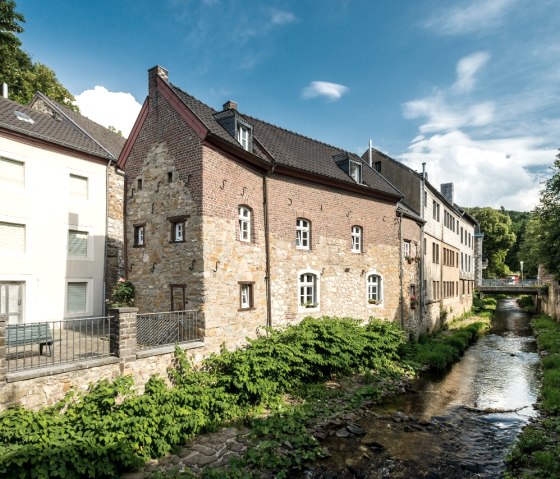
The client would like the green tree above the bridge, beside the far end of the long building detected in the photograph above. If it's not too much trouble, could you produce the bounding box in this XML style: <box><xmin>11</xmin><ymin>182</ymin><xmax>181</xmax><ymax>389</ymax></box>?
<box><xmin>467</xmin><ymin>207</ymin><xmax>515</xmax><ymax>278</ymax></box>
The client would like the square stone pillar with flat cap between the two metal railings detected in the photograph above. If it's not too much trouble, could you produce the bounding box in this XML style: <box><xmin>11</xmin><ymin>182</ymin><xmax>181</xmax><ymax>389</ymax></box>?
<box><xmin>109</xmin><ymin>308</ymin><xmax>138</xmax><ymax>374</ymax></box>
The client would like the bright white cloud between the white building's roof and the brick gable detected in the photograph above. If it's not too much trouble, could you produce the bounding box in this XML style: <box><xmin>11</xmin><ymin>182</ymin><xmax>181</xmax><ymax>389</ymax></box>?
<box><xmin>76</xmin><ymin>85</ymin><xmax>142</xmax><ymax>137</ymax></box>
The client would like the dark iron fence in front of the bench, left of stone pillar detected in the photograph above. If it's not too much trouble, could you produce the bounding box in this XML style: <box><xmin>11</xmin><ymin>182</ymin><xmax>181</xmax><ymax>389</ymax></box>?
<box><xmin>5</xmin><ymin>316</ymin><xmax>111</xmax><ymax>371</ymax></box>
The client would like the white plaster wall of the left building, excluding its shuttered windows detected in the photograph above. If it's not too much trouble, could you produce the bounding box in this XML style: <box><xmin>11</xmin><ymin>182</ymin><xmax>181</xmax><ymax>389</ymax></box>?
<box><xmin>0</xmin><ymin>136</ymin><xmax>107</xmax><ymax>323</ymax></box>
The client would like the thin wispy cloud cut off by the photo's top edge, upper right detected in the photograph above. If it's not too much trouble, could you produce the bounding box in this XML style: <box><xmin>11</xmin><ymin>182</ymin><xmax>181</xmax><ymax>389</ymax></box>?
<box><xmin>424</xmin><ymin>0</ymin><xmax>517</xmax><ymax>35</ymax></box>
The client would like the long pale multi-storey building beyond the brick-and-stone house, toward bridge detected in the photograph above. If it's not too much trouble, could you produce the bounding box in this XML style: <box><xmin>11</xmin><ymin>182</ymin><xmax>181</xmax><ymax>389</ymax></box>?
<box><xmin>362</xmin><ymin>148</ymin><xmax>476</xmax><ymax>329</ymax></box>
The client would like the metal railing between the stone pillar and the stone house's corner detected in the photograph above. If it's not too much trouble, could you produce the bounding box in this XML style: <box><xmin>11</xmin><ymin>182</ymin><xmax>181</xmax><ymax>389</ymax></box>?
<box><xmin>136</xmin><ymin>310</ymin><xmax>203</xmax><ymax>349</ymax></box>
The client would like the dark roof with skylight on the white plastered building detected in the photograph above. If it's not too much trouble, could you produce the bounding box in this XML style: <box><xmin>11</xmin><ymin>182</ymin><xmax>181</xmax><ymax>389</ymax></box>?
<box><xmin>0</xmin><ymin>95</ymin><xmax>125</xmax><ymax>160</ymax></box>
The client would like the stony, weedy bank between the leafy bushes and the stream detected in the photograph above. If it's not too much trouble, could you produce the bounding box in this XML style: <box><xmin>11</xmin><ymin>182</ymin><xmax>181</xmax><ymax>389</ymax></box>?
<box><xmin>137</xmin><ymin>314</ymin><xmax>490</xmax><ymax>479</ymax></box>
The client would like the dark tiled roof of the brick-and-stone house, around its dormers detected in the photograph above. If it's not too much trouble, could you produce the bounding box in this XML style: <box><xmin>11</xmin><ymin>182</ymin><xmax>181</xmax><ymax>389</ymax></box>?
<box><xmin>168</xmin><ymin>82</ymin><xmax>403</xmax><ymax>198</ymax></box>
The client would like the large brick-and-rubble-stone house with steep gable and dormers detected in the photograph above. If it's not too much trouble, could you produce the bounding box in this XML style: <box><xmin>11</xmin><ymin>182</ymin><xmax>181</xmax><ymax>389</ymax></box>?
<box><xmin>119</xmin><ymin>66</ymin><xmax>423</xmax><ymax>349</ymax></box>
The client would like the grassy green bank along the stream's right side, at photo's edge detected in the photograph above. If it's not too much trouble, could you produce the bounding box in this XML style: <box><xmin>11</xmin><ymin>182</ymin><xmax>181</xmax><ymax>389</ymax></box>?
<box><xmin>506</xmin><ymin>316</ymin><xmax>560</xmax><ymax>479</ymax></box>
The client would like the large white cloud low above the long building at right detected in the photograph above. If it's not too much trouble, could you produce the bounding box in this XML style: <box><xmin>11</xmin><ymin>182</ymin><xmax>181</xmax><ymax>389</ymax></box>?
<box><xmin>401</xmin><ymin>130</ymin><xmax>556</xmax><ymax>211</ymax></box>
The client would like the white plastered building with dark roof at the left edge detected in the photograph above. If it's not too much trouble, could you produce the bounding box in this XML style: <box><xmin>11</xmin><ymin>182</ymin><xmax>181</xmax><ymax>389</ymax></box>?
<box><xmin>0</xmin><ymin>93</ymin><xmax>124</xmax><ymax>323</ymax></box>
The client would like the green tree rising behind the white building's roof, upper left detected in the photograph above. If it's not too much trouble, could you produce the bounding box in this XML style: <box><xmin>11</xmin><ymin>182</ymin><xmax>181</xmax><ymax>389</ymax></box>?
<box><xmin>0</xmin><ymin>0</ymin><xmax>78</xmax><ymax>111</ymax></box>
